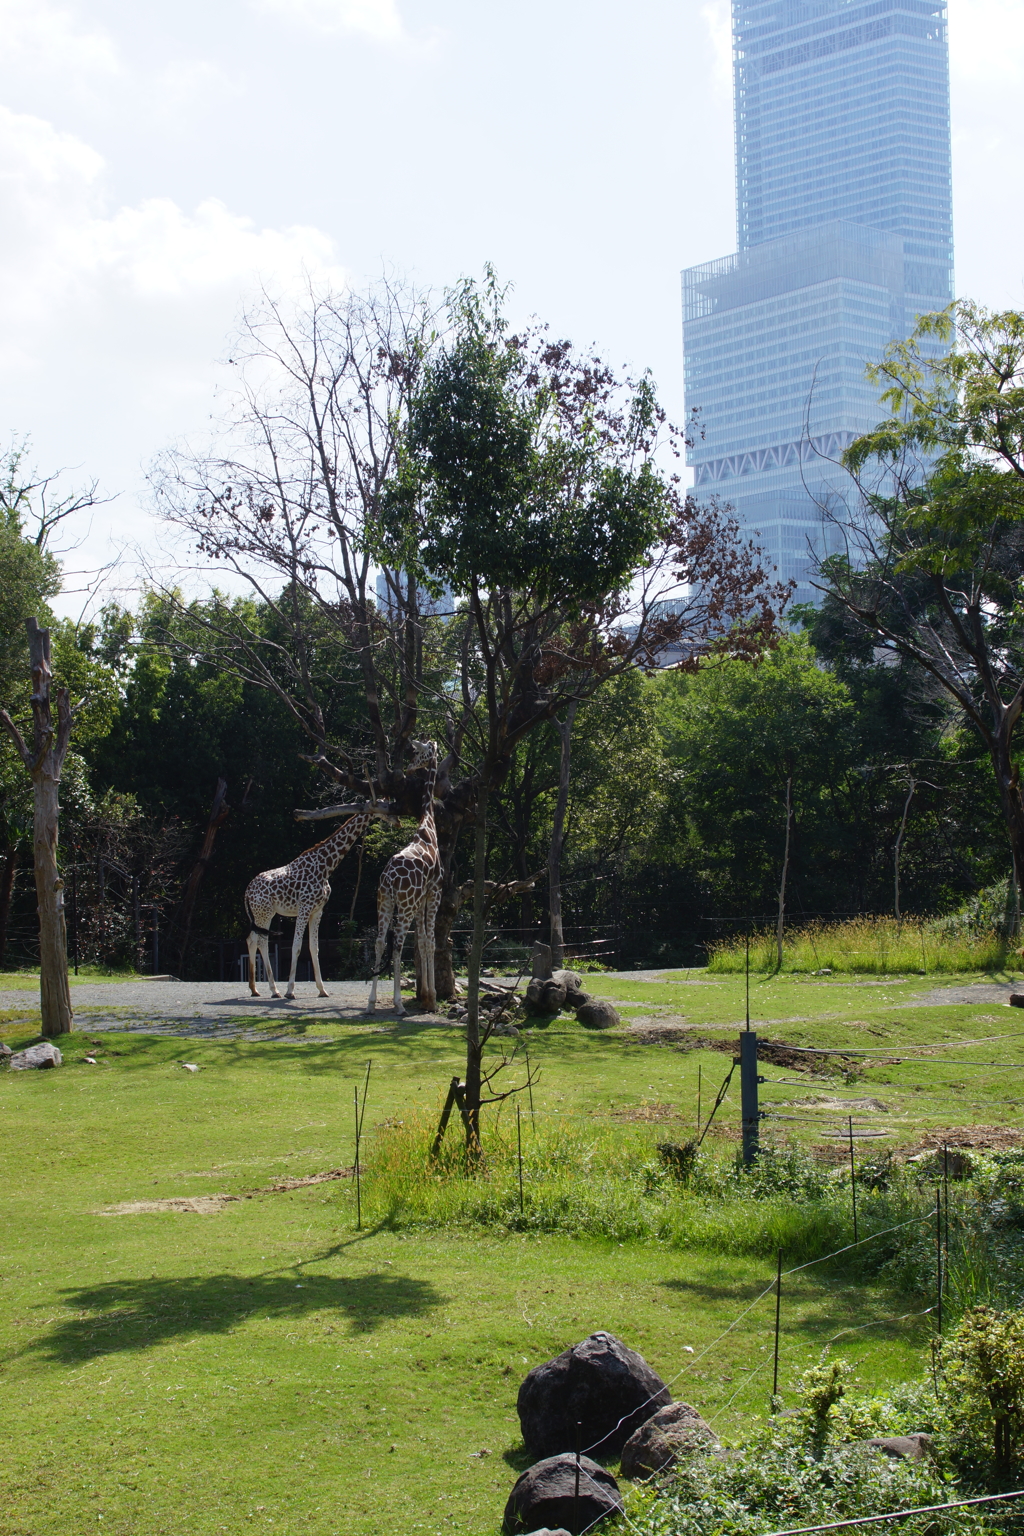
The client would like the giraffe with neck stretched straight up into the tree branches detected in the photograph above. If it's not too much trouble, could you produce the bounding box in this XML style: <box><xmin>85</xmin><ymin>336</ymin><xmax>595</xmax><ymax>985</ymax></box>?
<box><xmin>367</xmin><ymin>742</ymin><xmax>442</xmax><ymax>1018</ymax></box>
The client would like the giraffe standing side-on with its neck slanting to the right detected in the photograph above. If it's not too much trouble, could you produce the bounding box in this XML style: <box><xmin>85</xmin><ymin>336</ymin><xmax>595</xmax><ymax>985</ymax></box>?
<box><xmin>246</xmin><ymin>802</ymin><xmax>399</xmax><ymax>997</ymax></box>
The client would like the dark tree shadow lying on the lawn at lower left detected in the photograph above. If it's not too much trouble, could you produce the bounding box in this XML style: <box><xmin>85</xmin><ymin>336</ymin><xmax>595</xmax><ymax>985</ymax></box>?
<box><xmin>28</xmin><ymin>1273</ymin><xmax>445</xmax><ymax>1364</ymax></box>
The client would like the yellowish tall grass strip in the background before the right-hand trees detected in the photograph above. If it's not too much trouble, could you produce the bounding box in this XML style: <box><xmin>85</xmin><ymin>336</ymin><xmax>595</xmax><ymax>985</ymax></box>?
<box><xmin>708</xmin><ymin>917</ymin><xmax>1009</xmax><ymax>975</ymax></box>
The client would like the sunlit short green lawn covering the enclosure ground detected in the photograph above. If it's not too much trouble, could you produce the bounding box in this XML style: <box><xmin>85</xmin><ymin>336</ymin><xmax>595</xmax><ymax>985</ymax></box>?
<box><xmin>0</xmin><ymin>972</ymin><xmax>1024</xmax><ymax>1536</ymax></box>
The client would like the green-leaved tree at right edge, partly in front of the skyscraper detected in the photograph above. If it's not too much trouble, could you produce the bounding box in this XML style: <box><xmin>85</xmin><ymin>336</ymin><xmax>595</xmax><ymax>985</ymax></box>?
<box><xmin>821</xmin><ymin>301</ymin><xmax>1024</xmax><ymax>922</ymax></box>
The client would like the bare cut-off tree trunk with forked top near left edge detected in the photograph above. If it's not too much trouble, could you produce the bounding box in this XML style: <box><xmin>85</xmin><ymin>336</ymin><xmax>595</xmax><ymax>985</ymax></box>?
<box><xmin>0</xmin><ymin>619</ymin><xmax>75</xmax><ymax>1040</ymax></box>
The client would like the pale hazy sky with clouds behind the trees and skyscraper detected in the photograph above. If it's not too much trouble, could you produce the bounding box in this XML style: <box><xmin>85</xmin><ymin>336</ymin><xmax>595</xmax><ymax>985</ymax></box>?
<box><xmin>0</xmin><ymin>0</ymin><xmax>1024</xmax><ymax>599</ymax></box>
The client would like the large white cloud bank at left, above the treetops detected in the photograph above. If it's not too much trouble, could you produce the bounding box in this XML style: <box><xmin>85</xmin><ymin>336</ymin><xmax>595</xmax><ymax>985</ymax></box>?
<box><xmin>0</xmin><ymin>106</ymin><xmax>345</xmax><ymax>561</ymax></box>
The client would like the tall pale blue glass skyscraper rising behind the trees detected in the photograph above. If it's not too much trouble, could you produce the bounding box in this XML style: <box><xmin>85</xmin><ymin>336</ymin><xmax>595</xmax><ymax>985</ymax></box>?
<box><xmin>683</xmin><ymin>0</ymin><xmax>953</xmax><ymax>601</ymax></box>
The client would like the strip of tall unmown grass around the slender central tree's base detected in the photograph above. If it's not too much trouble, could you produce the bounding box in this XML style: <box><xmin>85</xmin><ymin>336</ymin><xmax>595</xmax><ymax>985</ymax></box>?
<box><xmin>364</xmin><ymin>1117</ymin><xmax>939</xmax><ymax>1272</ymax></box>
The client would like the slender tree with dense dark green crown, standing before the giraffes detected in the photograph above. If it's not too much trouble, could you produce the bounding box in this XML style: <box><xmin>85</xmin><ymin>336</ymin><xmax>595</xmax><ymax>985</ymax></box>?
<box><xmin>381</xmin><ymin>272</ymin><xmax>774</xmax><ymax>1144</ymax></box>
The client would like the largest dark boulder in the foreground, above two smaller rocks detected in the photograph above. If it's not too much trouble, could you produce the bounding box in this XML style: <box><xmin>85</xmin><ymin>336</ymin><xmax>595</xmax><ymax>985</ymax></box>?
<box><xmin>516</xmin><ymin>1332</ymin><xmax>672</xmax><ymax>1456</ymax></box>
